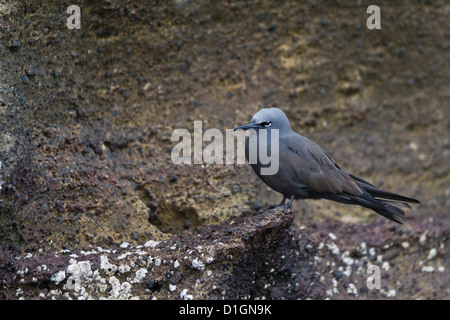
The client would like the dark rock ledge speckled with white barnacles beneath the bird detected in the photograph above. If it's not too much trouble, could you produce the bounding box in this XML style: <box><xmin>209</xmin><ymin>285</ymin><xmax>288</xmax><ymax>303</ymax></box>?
<box><xmin>0</xmin><ymin>208</ymin><xmax>450</xmax><ymax>300</ymax></box>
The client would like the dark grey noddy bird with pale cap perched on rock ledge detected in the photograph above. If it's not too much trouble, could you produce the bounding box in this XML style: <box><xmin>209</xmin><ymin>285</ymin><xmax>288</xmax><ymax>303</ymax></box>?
<box><xmin>234</xmin><ymin>108</ymin><xmax>420</xmax><ymax>223</ymax></box>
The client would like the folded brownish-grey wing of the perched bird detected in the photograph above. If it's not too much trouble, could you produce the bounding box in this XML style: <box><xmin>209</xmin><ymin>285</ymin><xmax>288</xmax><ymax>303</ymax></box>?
<box><xmin>280</xmin><ymin>134</ymin><xmax>363</xmax><ymax>195</ymax></box>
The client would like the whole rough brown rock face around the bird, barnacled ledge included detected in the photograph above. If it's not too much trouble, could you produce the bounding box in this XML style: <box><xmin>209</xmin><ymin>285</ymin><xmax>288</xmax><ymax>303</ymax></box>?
<box><xmin>0</xmin><ymin>1</ymin><xmax>450</xmax><ymax>299</ymax></box>
